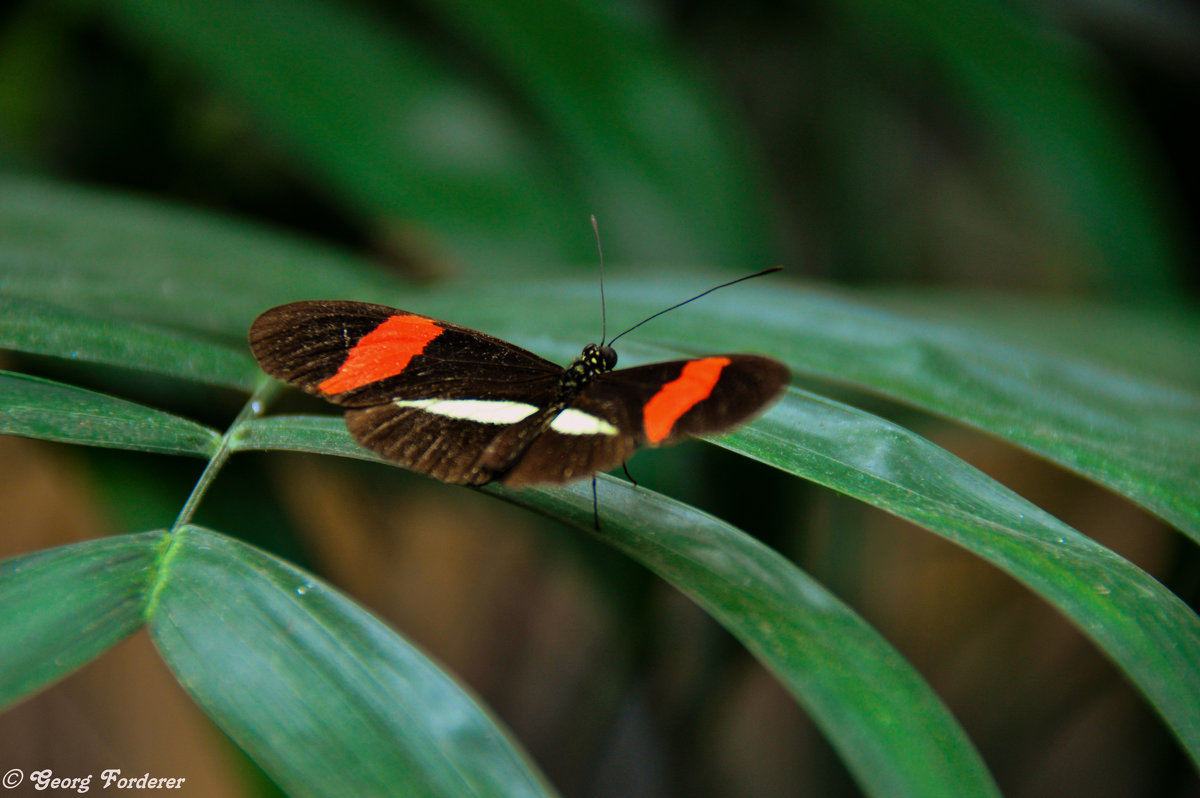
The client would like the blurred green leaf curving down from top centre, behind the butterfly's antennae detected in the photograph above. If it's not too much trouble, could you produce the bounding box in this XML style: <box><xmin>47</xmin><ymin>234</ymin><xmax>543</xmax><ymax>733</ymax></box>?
<box><xmin>412</xmin><ymin>0</ymin><xmax>768</xmax><ymax>269</ymax></box>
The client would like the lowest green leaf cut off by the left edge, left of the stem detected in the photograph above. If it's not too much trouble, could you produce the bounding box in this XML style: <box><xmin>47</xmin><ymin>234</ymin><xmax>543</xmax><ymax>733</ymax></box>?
<box><xmin>0</xmin><ymin>532</ymin><xmax>163</xmax><ymax>707</ymax></box>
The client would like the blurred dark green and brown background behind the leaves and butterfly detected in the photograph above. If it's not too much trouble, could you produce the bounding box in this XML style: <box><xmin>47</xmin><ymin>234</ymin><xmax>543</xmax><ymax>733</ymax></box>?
<box><xmin>0</xmin><ymin>0</ymin><xmax>1200</xmax><ymax>796</ymax></box>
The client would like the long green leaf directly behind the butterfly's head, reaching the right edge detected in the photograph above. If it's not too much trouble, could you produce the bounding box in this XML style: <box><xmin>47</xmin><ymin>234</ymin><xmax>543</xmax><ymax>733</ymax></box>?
<box><xmin>434</xmin><ymin>277</ymin><xmax>1200</xmax><ymax>540</ymax></box>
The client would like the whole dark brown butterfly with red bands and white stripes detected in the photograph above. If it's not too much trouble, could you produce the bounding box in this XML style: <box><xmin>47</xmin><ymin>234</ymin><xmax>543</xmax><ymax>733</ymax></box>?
<box><xmin>250</xmin><ymin>300</ymin><xmax>788</xmax><ymax>487</ymax></box>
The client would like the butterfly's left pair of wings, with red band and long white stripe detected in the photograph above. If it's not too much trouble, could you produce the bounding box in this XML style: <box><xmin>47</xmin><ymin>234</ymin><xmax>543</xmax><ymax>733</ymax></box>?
<box><xmin>250</xmin><ymin>301</ymin><xmax>563</xmax><ymax>485</ymax></box>
